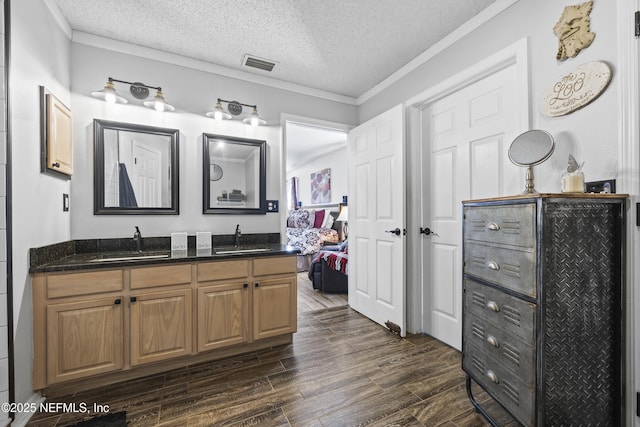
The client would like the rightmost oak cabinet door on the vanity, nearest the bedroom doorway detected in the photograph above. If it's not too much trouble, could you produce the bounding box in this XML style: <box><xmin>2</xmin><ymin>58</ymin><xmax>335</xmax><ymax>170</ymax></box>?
<box><xmin>253</xmin><ymin>275</ymin><xmax>298</xmax><ymax>340</ymax></box>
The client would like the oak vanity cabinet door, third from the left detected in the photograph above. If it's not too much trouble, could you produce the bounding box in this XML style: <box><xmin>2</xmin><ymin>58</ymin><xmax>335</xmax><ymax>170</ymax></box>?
<box><xmin>198</xmin><ymin>282</ymin><xmax>249</xmax><ymax>351</ymax></box>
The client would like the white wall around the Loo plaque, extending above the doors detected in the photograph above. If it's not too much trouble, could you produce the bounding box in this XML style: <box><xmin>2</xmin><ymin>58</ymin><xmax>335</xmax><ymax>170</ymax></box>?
<box><xmin>359</xmin><ymin>0</ymin><xmax>632</xmax><ymax>192</ymax></box>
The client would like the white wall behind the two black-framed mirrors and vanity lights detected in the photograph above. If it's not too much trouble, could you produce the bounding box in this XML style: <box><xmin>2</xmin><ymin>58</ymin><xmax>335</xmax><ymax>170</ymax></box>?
<box><xmin>71</xmin><ymin>43</ymin><xmax>356</xmax><ymax>239</ymax></box>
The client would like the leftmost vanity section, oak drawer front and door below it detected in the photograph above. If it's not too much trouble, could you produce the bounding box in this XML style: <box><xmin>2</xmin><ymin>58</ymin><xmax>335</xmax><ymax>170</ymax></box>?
<box><xmin>33</xmin><ymin>270</ymin><xmax>124</xmax><ymax>388</ymax></box>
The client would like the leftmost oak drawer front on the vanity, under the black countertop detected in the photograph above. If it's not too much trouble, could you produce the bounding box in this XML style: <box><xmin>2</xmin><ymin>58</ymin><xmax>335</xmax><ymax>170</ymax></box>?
<box><xmin>47</xmin><ymin>270</ymin><xmax>124</xmax><ymax>298</ymax></box>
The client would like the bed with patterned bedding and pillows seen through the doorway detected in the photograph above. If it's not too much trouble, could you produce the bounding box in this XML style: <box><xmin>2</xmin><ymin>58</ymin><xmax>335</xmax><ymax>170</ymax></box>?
<box><xmin>287</xmin><ymin>209</ymin><xmax>340</xmax><ymax>271</ymax></box>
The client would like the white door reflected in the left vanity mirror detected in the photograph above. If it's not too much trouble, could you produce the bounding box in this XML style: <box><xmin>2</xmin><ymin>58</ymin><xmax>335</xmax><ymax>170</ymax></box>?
<box><xmin>132</xmin><ymin>141</ymin><xmax>163</xmax><ymax>207</ymax></box>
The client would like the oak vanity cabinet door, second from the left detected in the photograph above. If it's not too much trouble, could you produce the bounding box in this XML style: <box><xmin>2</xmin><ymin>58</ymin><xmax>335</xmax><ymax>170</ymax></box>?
<box><xmin>129</xmin><ymin>289</ymin><xmax>193</xmax><ymax>366</ymax></box>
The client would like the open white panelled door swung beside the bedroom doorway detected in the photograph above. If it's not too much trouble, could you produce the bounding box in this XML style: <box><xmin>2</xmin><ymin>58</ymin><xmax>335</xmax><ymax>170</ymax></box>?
<box><xmin>348</xmin><ymin>105</ymin><xmax>406</xmax><ymax>336</ymax></box>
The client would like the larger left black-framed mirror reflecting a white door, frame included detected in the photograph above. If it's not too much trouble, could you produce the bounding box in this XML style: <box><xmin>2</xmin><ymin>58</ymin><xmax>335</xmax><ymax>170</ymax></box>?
<box><xmin>93</xmin><ymin>119</ymin><xmax>180</xmax><ymax>215</ymax></box>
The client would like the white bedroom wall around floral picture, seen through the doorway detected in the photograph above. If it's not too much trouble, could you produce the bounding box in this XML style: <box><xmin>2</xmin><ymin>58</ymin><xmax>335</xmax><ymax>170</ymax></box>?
<box><xmin>283</xmin><ymin>146</ymin><xmax>348</xmax><ymax>206</ymax></box>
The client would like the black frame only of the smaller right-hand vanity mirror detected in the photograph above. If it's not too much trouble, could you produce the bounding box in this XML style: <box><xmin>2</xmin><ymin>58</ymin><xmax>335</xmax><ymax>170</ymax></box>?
<box><xmin>202</xmin><ymin>133</ymin><xmax>267</xmax><ymax>215</ymax></box>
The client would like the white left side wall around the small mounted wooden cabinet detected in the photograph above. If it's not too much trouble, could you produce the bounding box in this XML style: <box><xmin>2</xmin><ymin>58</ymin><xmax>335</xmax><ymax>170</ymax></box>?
<box><xmin>10</xmin><ymin>0</ymin><xmax>75</xmax><ymax>412</ymax></box>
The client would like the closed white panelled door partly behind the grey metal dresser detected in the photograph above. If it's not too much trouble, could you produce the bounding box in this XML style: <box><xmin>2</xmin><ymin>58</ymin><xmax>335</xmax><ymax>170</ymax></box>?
<box><xmin>421</xmin><ymin>66</ymin><xmax>524</xmax><ymax>349</ymax></box>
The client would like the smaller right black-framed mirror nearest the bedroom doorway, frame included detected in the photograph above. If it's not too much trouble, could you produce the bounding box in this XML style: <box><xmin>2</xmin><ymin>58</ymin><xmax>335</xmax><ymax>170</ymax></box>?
<box><xmin>202</xmin><ymin>133</ymin><xmax>267</xmax><ymax>214</ymax></box>
